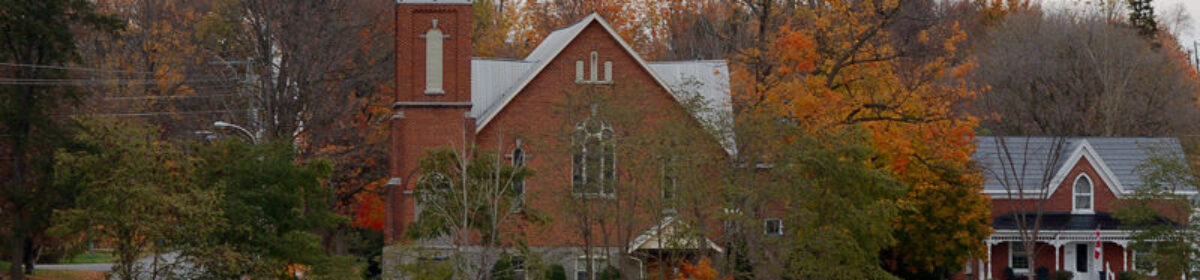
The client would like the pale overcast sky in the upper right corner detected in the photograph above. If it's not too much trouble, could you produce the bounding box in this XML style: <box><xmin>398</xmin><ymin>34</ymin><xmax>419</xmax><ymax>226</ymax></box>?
<box><xmin>1034</xmin><ymin>0</ymin><xmax>1200</xmax><ymax>49</ymax></box>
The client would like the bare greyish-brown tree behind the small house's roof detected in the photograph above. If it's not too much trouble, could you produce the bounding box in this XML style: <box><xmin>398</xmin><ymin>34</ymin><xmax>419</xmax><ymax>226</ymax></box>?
<box><xmin>970</xmin><ymin>11</ymin><xmax>1200</xmax><ymax>136</ymax></box>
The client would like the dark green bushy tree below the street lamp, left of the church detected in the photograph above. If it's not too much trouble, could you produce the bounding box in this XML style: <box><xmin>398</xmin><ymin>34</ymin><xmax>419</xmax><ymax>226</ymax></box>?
<box><xmin>181</xmin><ymin>141</ymin><xmax>358</xmax><ymax>279</ymax></box>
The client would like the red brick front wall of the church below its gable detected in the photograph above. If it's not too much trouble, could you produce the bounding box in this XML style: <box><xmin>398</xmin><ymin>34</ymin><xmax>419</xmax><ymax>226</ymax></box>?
<box><xmin>478</xmin><ymin>23</ymin><xmax>724</xmax><ymax>246</ymax></box>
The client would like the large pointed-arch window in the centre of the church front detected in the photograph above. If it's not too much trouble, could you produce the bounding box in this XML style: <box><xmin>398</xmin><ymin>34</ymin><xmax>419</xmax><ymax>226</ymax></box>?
<box><xmin>571</xmin><ymin>106</ymin><xmax>617</xmax><ymax>197</ymax></box>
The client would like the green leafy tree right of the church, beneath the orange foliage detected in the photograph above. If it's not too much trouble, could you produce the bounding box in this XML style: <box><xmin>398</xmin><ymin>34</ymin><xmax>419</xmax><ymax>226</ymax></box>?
<box><xmin>775</xmin><ymin>130</ymin><xmax>906</xmax><ymax>279</ymax></box>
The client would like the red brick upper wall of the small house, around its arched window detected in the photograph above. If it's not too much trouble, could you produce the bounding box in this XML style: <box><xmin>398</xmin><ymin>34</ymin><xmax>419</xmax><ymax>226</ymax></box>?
<box><xmin>991</xmin><ymin>157</ymin><xmax>1116</xmax><ymax>218</ymax></box>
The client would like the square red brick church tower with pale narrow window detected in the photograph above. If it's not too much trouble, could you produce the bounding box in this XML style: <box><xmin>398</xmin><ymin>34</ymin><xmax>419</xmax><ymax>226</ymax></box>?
<box><xmin>384</xmin><ymin>0</ymin><xmax>475</xmax><ymax>244</ymax></box>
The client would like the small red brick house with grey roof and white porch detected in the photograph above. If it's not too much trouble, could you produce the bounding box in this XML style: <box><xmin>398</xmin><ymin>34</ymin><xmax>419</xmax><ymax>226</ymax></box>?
<box><xmin>965</xmin><ymin>137</ymin><xmax>1195</xmax><ymax>280</ymax></box>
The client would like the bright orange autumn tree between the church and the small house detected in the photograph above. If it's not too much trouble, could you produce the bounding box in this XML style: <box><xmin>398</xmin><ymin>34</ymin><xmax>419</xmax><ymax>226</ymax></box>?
<box><xmin>739</xmin><ymin>0</ymin><xmax>990</xmax><ymax>278</ymax></box>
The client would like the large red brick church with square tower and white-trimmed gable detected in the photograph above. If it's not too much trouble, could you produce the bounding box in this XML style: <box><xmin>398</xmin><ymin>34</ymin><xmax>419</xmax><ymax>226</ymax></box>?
<box><xmin>384</xmin><ymin>0</ymin><xmax>734</xmax><ymax>279</ymax></box>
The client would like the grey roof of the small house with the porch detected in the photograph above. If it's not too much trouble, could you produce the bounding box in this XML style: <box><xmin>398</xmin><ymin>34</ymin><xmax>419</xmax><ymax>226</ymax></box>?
<box><xmin>972</xmin><ymin>136</ymin><xmax>1184</xmax><ymax>192</ymax></box>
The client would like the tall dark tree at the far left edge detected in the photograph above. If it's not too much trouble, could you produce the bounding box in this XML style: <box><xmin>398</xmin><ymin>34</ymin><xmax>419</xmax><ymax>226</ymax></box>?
<box><xmin>0</xmin><ymin>0</ymin><xmax>120</xmax><ymax>280</ymax></box>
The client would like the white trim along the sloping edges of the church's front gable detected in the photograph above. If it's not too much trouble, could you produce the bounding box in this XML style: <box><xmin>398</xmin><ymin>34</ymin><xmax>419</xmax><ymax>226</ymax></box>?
<box><xmin>475</xmin><ymin>13</ymin><xmax>703</xmax><ymax>133</ymax></box>
